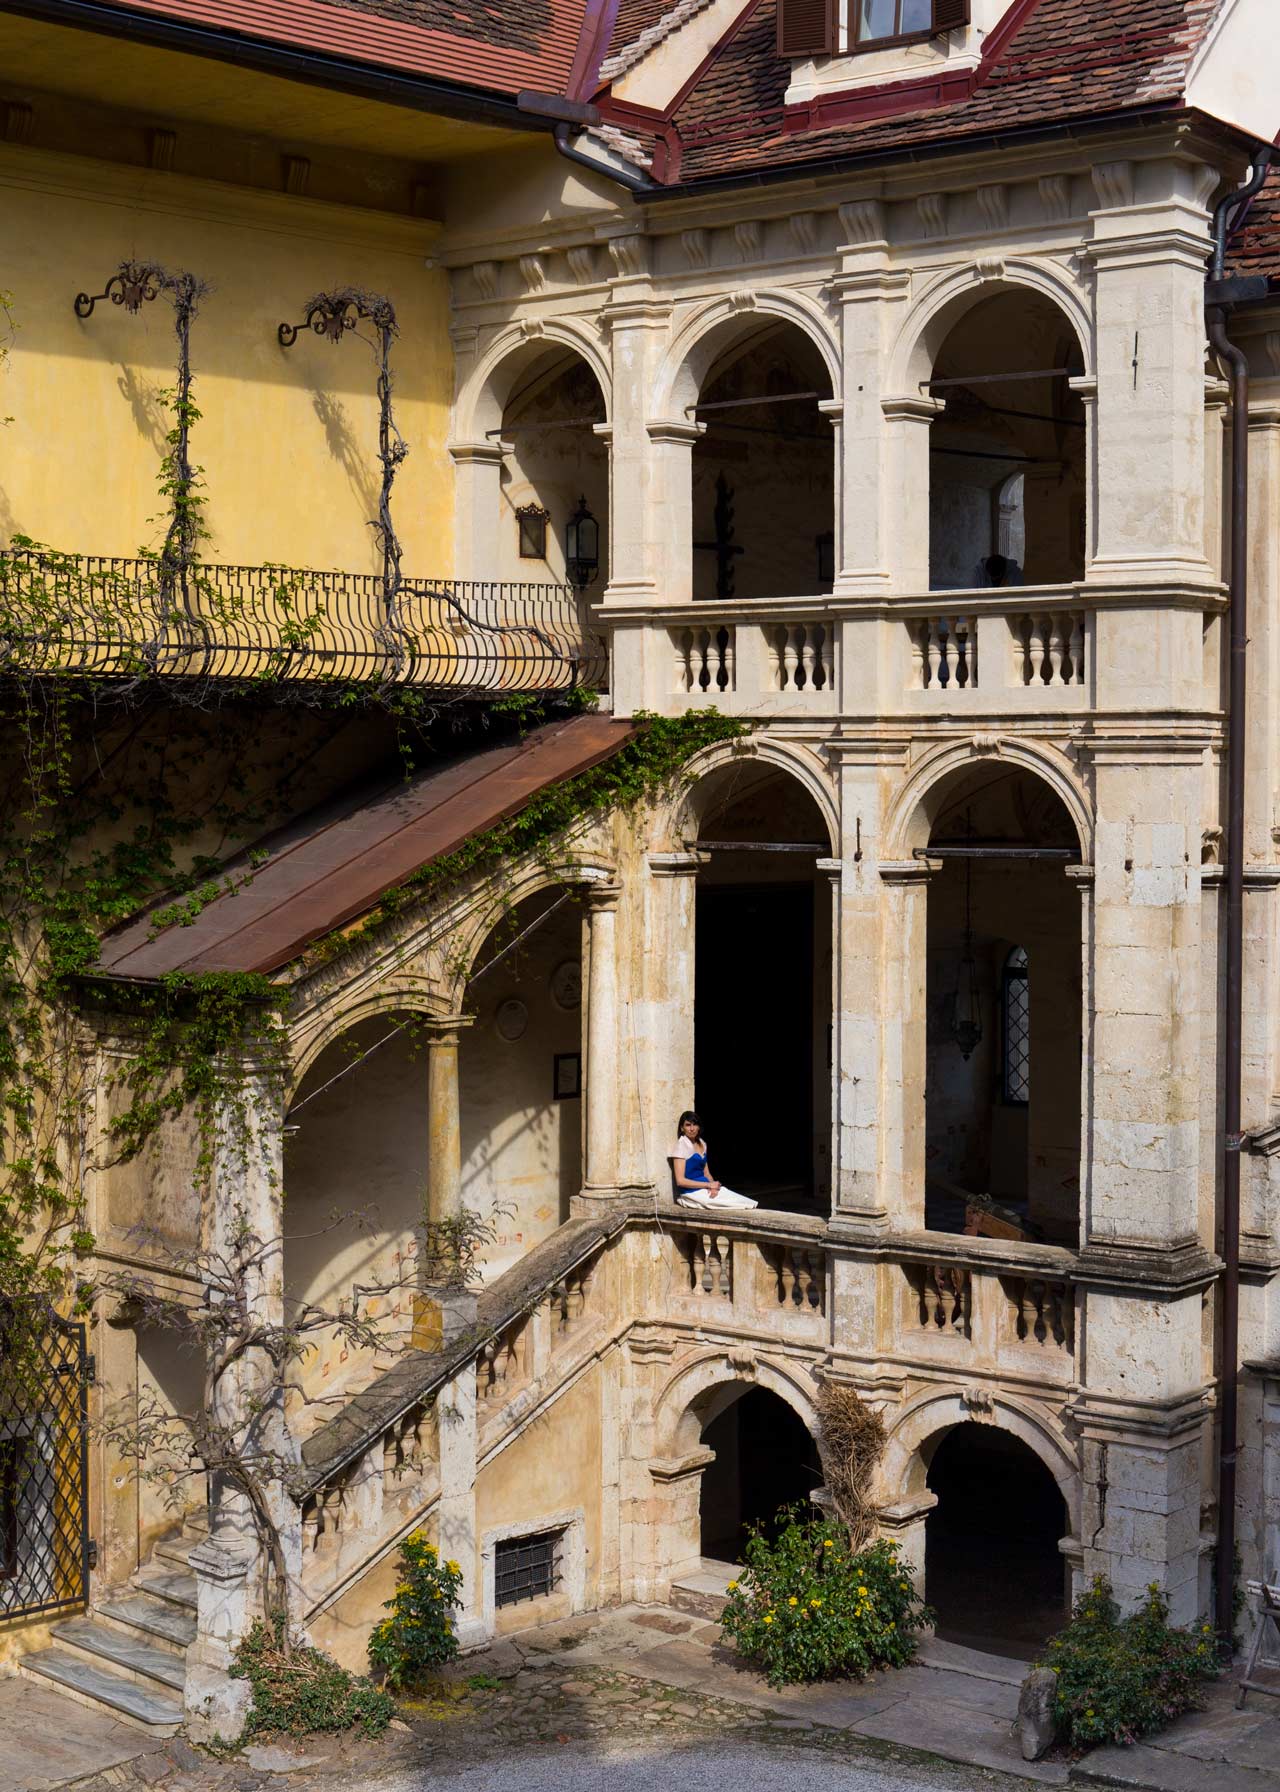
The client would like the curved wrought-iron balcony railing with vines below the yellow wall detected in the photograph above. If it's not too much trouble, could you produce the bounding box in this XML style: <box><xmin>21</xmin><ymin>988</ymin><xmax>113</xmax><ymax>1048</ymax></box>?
<box><xmin>0</xmin><ymin>547</ymin><xmax>606</xmax><ymax>695</ymax></box>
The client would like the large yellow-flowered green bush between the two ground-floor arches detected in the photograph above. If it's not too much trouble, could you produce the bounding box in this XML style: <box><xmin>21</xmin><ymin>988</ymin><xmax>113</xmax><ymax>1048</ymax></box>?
<box><xmin>721</xmin><ymin>1505</ymin><xmax>930</xmax><ymax>1686</ymax></box>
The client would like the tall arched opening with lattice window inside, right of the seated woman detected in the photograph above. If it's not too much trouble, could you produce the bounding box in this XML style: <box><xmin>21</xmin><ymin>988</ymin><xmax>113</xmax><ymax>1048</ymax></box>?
<box><xmin>923</xmin><ymin>762</ymin><xmax>1083</xmax><ymax>1245</ymax></box>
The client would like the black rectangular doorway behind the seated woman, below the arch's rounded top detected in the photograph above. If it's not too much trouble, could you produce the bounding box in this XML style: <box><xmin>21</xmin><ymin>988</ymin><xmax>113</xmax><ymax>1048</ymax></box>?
<box><xmin>694</xmin><ymin>882</ymin><xmax>814</xmax><ymax>1208</ymax></box>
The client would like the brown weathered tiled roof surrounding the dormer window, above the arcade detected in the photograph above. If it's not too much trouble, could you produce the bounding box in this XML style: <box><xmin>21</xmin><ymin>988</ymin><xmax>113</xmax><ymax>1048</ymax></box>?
<box><xmin>604</xmin><ymin>0</ymin><xmax>1221</xmax><ymax>185</ymax></box>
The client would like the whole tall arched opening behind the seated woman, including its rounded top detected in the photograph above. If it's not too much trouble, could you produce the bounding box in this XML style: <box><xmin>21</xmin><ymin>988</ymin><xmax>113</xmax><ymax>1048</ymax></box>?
<box><xmin>692</xmin><ymin>760</ymin><xmax>832</xmax><ymax>1211</ymax></box>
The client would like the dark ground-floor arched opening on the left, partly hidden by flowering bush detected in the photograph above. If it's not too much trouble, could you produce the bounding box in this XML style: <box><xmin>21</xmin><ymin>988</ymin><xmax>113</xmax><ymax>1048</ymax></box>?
<box><xmin>701</xmin><ymin>1387</ymin><xmax>823</xmax><ymax>1563</ymax></box>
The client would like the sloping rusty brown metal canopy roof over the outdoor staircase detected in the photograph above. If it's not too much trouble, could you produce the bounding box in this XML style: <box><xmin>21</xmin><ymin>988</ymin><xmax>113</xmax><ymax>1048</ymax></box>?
<box><xmin>99</xmin><ymin>715</ymin><xmax>636</xmax><ymax>978</ymax></box>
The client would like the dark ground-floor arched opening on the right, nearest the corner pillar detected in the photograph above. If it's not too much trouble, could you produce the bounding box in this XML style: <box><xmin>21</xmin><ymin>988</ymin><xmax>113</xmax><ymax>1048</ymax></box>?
<box><xmin>925</xmin><ymin>1425</ymin><xmax>1068</xmax><ymax>1661</ymax></box>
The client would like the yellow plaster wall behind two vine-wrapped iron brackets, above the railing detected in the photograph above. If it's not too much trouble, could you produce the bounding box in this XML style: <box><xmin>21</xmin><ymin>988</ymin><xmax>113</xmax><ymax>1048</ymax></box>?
<box><xmin>0</xmin><ymin>145</ymin><xmax>452</xmax><ymax>575</ymax></box>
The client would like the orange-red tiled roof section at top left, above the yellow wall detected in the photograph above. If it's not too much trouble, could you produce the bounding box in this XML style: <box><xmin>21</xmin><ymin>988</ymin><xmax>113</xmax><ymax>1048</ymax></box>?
<box><xmin>87</xmin><ymin>0</ymin><xmax>599</xmax><ymax>97</ymax></box>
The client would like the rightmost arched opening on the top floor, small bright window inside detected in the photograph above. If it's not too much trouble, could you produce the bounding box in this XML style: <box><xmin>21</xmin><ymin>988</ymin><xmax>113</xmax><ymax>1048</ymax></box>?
<box><xmin>929</xmin><ymin>290</ymin><xmax>1086</xmax><ymax>591</ymax></box>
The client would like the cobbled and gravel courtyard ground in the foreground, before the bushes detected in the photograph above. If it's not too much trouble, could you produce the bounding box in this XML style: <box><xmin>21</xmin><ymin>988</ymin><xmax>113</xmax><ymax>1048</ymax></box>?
<box><xmin>24</xmin><ymin>1607</ymin><xmax>1280</xmax><ymax>1792</ymax></box>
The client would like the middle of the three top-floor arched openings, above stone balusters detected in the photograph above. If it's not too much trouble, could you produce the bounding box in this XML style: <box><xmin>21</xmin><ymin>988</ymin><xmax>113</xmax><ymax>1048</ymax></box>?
<box><xmin>692</xmin><ymin>315</ymin><xmax>835</xmax><ymax>602</ymax></box>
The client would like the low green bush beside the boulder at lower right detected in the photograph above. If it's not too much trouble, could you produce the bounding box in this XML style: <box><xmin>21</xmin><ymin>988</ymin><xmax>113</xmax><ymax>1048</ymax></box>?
<box><xmin>1043</xmin><ymin>1575</ymin><xmax>1221</xmax><ymax>1747</ymax></box>
